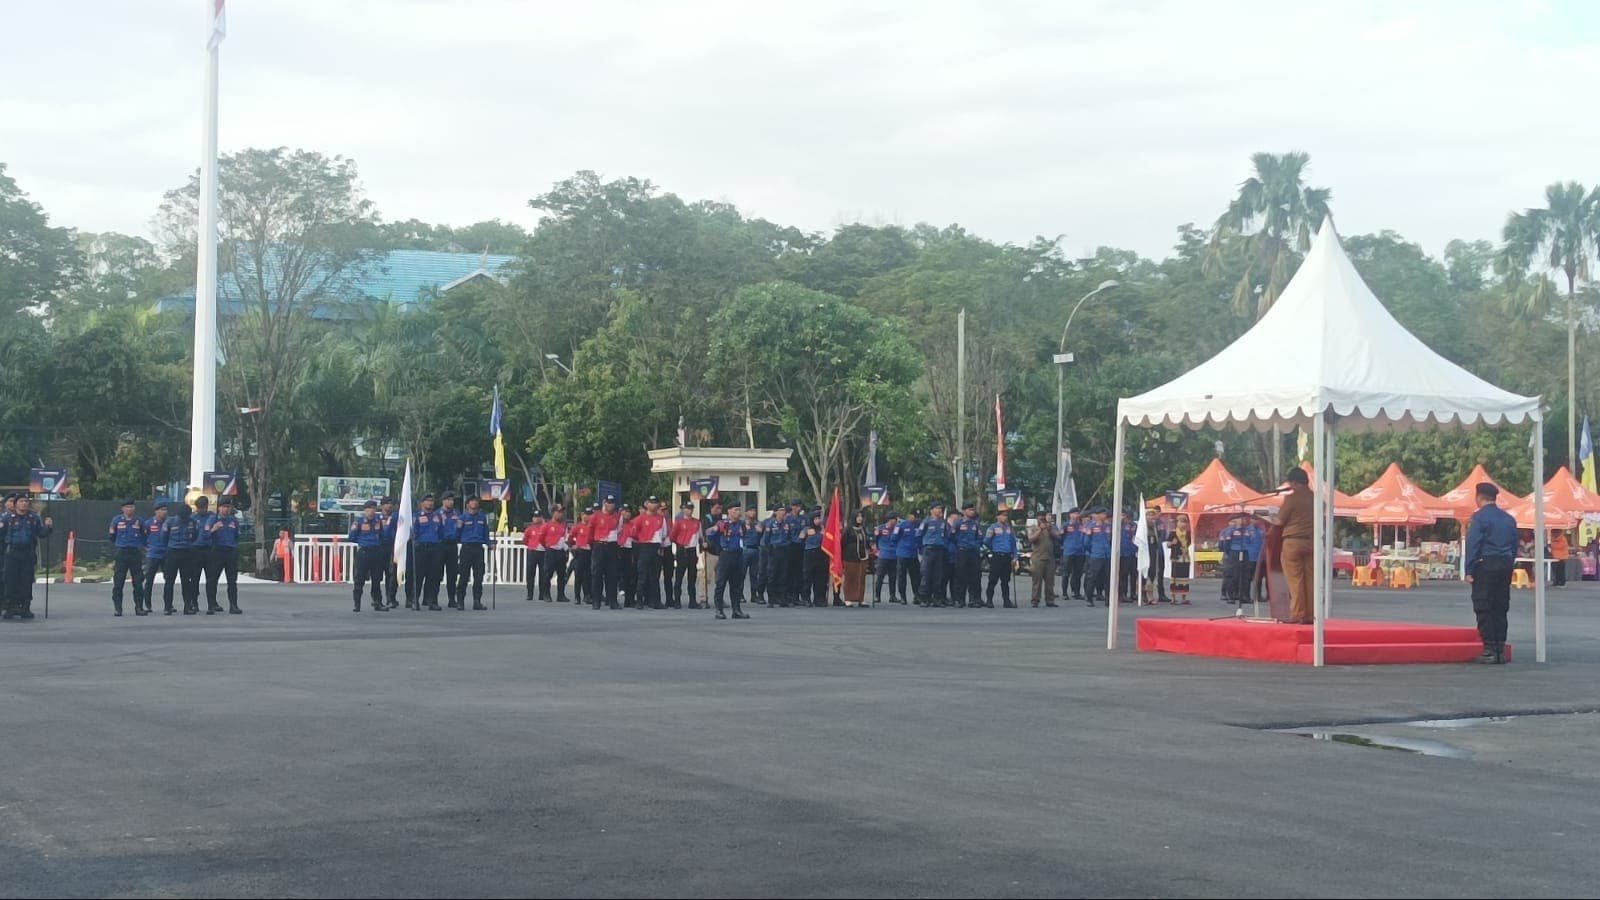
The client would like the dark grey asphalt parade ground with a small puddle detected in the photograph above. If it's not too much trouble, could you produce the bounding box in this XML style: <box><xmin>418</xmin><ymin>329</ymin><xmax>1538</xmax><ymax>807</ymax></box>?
<box><xmin>0</xmin><ymin>570</ymin><xmax>1600</xmax><ymax>897</ymax></box>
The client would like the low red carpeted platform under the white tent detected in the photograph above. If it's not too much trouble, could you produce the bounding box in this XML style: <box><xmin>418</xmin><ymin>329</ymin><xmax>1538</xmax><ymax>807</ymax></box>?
<box><xmin>1138</xmin><ymin>618</ymin><xmax>1510</xmax><ymax>666</ymax></box>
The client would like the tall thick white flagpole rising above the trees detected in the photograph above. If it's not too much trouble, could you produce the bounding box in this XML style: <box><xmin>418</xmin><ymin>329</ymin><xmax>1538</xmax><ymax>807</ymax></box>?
<box><xmin>189</xmin><ymin>0</ymin><xmax>224</xmax><ymax>488</ymax></box>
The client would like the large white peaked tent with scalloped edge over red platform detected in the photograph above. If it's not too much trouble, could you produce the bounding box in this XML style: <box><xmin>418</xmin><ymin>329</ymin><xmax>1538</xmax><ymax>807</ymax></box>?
<box><xmin>1106</xmin><ymin>218</ymin><xmax>1546</xmax><ymax>666</ymax></box>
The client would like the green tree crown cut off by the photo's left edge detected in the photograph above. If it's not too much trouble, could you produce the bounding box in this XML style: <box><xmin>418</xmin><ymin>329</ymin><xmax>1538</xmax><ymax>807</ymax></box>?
<box><xmin>0</xmin><ymin>163</ymin><xmax>82</xmax><ymax>320</ymax></box>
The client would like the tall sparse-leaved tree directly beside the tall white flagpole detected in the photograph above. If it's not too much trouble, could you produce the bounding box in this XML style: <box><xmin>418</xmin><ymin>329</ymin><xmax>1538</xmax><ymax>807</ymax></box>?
<box><xmin>157</xmin><ymin>147</ymin><xmax>378</xmax><ymax>565</ymax></box>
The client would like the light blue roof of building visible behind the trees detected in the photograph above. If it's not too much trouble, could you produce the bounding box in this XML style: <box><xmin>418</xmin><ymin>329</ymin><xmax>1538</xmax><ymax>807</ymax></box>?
<box><xmin>155</xmin><ymin>250</ymin><xmax>515</xmax><ymax>319</ymax></box>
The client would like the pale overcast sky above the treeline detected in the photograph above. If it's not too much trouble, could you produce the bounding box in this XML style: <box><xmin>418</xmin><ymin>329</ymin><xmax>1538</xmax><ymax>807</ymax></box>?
<box><xmin>0</xmin><ymin>0</ymin><xmax>1600</xmax><ymax>256</ymax></box>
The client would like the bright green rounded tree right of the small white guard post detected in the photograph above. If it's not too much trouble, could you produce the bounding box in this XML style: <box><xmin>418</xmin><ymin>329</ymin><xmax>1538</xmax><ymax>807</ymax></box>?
<box><xmin>710</xmin><ymin>282</ymin><xmax>920</xmax><ymax>503</ymax></box>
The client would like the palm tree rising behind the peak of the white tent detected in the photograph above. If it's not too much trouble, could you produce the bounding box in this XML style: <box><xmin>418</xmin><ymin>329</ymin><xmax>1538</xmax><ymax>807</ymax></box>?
<box><xmin>1206</xmin><ymin>151</ymin><xmax>1333</xmax><ymax>319</ymax></box>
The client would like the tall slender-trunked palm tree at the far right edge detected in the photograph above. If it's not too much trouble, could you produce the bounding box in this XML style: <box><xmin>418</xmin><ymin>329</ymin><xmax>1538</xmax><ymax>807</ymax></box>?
<box><xmin>1494</xmin><ymin>181</ymin><xmax>1600</xmax><ymax>472</ymax></box>
